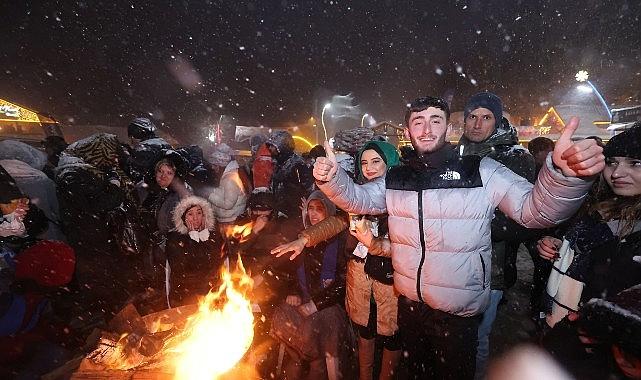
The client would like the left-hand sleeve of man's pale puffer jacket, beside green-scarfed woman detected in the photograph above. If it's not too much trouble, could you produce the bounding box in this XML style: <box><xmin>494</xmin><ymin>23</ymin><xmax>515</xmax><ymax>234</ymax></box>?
<box><xmin>316</xmin><ymin>168</ymin><xmax>387</xmax><ymax>215</ymax></box>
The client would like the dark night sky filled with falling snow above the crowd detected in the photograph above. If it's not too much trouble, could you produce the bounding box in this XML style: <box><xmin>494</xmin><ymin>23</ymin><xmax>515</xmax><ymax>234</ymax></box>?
<box><xmin>0</xmin><ymin>0</ymin><xmax>641</xmax><ymax>142</ymax></box>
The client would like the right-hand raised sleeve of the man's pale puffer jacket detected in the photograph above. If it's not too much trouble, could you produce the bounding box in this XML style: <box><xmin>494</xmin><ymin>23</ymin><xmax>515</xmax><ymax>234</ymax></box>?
<box><xmin>480</xmin><ymin>155</ymin><xmax>593</xmax><ymax>228</ymax></box>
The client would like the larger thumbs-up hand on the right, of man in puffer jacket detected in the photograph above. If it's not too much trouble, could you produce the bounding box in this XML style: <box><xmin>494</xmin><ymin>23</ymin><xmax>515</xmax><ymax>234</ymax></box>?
<box><xmin>552</xmin><ymin>117</ymin><xmax>605</xmax><ymax>177</ymax></box>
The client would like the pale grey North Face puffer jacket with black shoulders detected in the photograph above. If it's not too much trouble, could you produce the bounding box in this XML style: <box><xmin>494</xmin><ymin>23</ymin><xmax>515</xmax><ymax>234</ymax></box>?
<box><xmin>319</xmin><ymin>153</ymin><xmax>591</xmax><ymax>316</ymax></box>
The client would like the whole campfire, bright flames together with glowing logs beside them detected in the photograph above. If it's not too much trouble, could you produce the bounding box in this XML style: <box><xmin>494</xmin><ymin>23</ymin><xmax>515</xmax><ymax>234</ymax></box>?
<box><xmin>80</xmin><ymin>258</ymin><xmax>254</xmax><ymax>379</ymax></box>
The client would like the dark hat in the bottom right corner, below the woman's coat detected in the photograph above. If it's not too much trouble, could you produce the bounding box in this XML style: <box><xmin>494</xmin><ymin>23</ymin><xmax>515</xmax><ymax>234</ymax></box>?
<box><xmin>580</xmin><ymin>285</ymin><xmax>641</xmax><ymax>358</ymax></box>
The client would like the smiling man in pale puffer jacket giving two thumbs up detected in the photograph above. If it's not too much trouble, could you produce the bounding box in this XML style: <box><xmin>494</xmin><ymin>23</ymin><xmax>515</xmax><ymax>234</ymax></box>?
<box><xmin>314</xmin><ymin>97</ymin><xmax>604</xmax><ymax>379</ymax></box>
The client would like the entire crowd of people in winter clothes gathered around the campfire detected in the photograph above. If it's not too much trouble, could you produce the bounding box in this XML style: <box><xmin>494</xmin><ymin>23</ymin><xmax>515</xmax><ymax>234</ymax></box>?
<box><xmin>0</xmin><ymin>92</ymin><xmax>641</xmax><ymax>380</ymax></box>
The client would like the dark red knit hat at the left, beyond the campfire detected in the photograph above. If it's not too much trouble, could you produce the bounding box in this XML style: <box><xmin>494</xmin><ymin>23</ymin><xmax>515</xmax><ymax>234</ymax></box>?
<box><xmin>15</xmin><ymin>240</ymin><xmax>76</xmax><ymax>286</ymax></box>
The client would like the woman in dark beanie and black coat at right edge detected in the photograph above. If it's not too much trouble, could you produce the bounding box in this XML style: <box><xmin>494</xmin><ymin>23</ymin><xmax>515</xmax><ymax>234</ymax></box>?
<box><xmin>538</xmin><ymin>122</ymin><xmax>641</xmax><ymax>379</ymax></box>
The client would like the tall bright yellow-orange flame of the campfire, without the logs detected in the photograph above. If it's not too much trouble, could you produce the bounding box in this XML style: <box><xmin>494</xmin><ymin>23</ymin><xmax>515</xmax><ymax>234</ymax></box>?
<box><xmin>171</xmin><ymin>257</ymin><xmax>254</xmax><ymax>379</ymax></box>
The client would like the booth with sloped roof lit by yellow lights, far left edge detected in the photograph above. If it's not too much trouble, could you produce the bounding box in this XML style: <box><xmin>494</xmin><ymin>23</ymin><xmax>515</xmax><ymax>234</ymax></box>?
<box><xmin>0</xmin><ymin>99</ymin><xmax>62</xmax><ymax>145</ymax></box>
